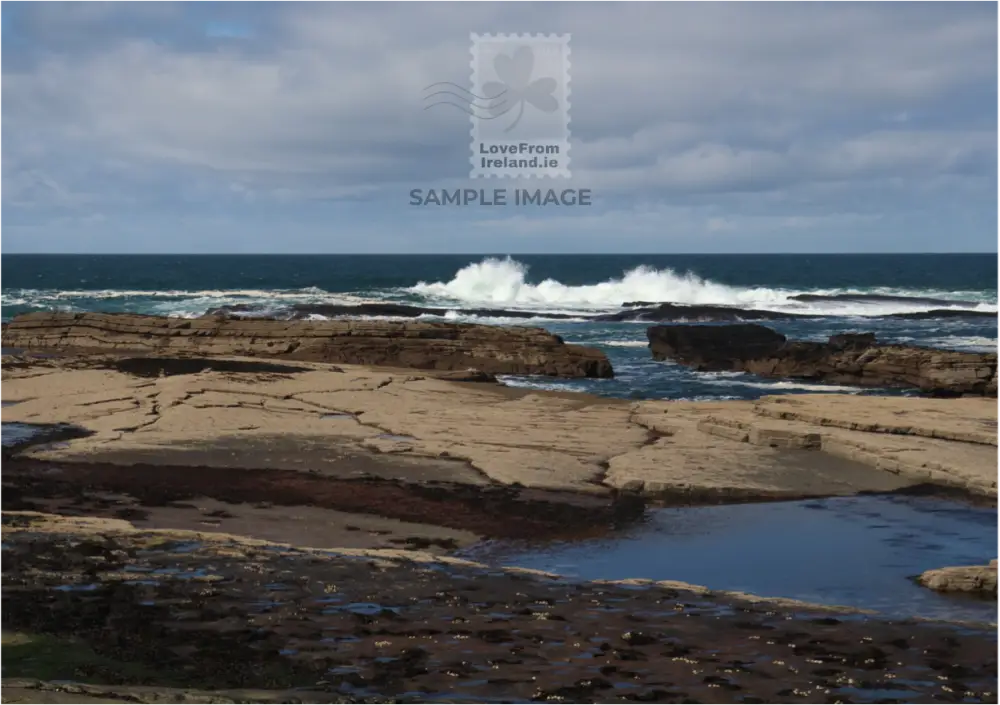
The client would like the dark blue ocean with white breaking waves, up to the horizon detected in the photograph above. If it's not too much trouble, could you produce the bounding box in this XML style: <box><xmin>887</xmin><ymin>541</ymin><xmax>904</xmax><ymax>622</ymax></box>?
<box><xmin>0</xmin><ymin>254</ymin><xmax>1000</xmax><ymax>400</ymax></box>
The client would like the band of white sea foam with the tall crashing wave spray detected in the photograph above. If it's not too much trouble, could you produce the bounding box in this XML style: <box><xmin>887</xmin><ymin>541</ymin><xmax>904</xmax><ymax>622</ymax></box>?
<box><xmin>0</xmin><ymin>257</ymin><xmax>1000</xmax><ymax>322</ymax></box>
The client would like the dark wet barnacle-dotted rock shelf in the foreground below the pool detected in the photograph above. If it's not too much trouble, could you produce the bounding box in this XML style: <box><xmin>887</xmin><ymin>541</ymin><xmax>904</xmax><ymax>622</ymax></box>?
<box><xmin>0</xmin><ymin>514</ymin><xmax>1000</xmax><ymax>704</ymax></box>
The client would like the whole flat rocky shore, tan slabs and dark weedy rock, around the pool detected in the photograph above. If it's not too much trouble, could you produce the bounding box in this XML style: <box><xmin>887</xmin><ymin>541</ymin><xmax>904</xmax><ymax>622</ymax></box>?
<box><xmin>0</xmin><ymin>319</ymin><xmax>1000</xmax><ymax>705</ymax></box>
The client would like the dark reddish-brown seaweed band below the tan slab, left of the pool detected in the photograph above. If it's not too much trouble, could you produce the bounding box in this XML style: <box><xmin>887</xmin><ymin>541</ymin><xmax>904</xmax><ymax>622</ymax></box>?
<box><xmin>0</xmin><ymin>458</ymin><xmax>644</xmax><ymax>543</ymax></box>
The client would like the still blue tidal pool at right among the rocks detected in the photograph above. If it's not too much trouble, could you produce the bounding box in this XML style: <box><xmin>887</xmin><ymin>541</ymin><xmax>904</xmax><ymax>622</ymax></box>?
<box><xmin>461</xmin><ymin>496</ymin><xmax>1000</xmax><ymax>622</ymax></box>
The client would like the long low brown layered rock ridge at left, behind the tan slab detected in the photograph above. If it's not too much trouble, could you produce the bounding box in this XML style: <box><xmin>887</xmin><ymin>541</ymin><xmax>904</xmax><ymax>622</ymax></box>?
<box><xmin>0</xmin><ymin>312</ymin><xmax>612</xmax><ymax>377</ymax></box>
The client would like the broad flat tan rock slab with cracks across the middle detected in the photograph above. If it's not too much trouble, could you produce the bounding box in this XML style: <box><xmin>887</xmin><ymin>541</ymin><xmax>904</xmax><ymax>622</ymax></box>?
<box><xmin>0</xmin><ymin>357</ymin><xmax>1000</xmax><ymax>502</ymax></box>
